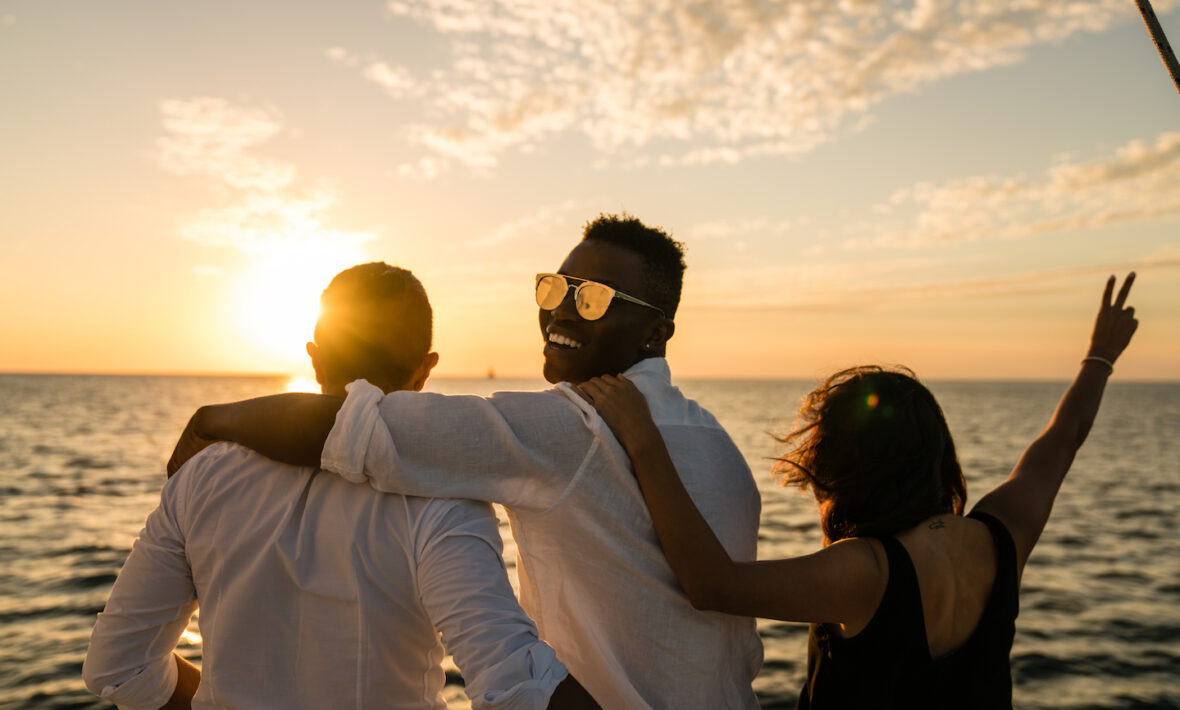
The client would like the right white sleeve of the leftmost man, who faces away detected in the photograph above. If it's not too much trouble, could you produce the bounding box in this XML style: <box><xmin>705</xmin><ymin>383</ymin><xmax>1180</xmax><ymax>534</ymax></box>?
<box><xmin>417</xmin><ymin>500</ymin><xmax>568</xmax><ymax>710</ymax></box>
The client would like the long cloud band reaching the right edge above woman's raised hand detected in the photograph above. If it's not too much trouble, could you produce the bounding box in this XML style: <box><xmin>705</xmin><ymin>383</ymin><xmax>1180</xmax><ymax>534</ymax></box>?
<box><xmin>846</xmin><ymin>132</ymin><xmax>1180</xmax><ymax>249</ymax></box>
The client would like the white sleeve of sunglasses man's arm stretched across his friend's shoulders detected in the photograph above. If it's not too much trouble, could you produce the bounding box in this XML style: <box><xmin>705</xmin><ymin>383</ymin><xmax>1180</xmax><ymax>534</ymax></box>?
<box><xmin>321</xmin><ymin>381</ymin><xmax>602</xmax><ymax>511</ymax></box>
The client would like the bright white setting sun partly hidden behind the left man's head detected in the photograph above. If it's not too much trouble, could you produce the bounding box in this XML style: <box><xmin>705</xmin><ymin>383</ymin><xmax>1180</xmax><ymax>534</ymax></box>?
<box><xmin>232</xmin><ymin>241</ymin><xmax>365</xmax><ymax>372</ymax></box>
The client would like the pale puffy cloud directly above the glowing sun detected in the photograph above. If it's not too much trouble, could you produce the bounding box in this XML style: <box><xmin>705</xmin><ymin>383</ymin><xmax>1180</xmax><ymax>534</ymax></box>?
<box><xmin>157</xmin><ymin>97</ymin><xmax>372</xmax><ymax>255</ymax></box>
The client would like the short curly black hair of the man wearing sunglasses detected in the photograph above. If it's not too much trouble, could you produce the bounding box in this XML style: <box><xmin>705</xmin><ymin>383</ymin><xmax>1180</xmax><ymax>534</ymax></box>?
<box><xmin>582</xmin><ymin>212</ymin><xmax>684</xmax><ymax>318</ymax></box>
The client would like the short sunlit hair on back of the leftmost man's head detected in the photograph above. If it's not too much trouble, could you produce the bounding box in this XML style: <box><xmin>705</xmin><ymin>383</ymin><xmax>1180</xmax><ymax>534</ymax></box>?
<box><xmin>315</xmin><ymin>262</ymin><xmax>433</xmax><ymax>383</ymax></box>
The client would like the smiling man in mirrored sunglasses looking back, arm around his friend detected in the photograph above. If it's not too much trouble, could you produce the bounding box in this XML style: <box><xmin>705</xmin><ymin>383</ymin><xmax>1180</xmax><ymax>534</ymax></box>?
<box><xmin>170</xmin><ymin>215</ymin><xmax>762</xmax><ymax>709</ymax></box>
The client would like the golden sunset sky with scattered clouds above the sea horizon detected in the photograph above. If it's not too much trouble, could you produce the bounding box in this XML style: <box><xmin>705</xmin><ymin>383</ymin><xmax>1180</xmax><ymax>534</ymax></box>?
<box><xmin>0</xmin><ymin>0</ymin><xmax>1180</xmax><ymax>380</ymax></box>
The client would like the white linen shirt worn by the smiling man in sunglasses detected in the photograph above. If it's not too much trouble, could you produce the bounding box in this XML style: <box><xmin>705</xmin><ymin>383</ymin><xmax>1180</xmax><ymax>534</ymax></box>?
<box><xmin>321</xmin><ymin>359</ymin><xmax>762</xmax><ymax>710</ymax></box>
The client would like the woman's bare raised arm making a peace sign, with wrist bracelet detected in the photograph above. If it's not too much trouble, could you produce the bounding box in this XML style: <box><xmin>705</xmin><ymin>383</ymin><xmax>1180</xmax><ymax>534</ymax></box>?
<box><xmin>975</xmin><ymin>272</ymin><xmax>1139</xmax><ymax>574</ymax></box>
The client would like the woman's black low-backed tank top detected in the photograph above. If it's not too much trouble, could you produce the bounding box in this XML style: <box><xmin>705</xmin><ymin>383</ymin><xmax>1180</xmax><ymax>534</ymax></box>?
<box><xmin>798</xmin><ymin>511</ymin><xmax>1018</xmax><ymax>710</ymax></box>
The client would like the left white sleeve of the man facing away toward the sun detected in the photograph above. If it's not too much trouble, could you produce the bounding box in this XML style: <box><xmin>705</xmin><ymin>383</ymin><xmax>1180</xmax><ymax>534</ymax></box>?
<box><xmin>83</xmin><ymin>458</ymin><xmax>203</xmax><ymax>710</ymax></box>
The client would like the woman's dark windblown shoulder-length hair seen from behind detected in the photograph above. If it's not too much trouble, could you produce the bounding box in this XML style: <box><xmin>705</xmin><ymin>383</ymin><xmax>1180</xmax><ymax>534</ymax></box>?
<box><xmin>775</xmin><ymin>366</ymin><xmax>966</xmax><ymax>543</ymax></box>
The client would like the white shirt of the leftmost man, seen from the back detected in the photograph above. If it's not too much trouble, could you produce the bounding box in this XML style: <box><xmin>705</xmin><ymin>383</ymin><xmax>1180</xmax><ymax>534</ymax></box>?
<box><xmin>83</xmin><ymin>443</ymin><xmax>566</xmax><ymax>710</ymax></box>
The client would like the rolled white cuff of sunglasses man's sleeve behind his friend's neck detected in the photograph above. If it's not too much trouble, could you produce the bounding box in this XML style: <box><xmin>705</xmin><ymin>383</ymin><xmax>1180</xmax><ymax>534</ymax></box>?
<box><xmin>320</xmin><ymin>380</ymin><xmax>393</xmax><ymax>484</ymax></box>
